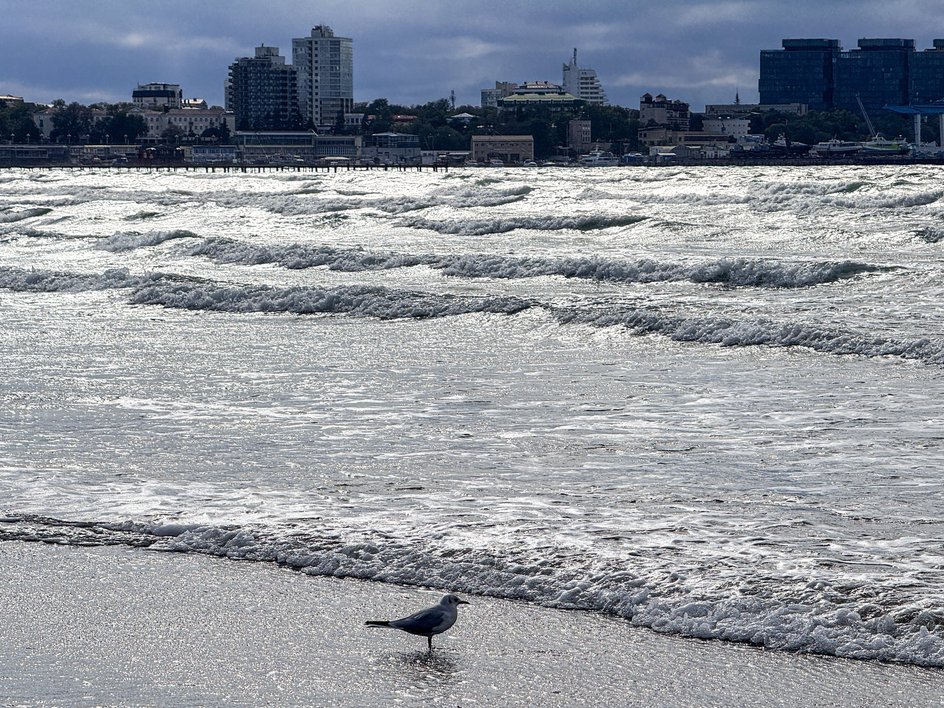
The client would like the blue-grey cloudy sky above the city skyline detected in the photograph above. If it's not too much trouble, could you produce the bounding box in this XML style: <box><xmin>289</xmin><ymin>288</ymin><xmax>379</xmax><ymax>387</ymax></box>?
<box><xmin>0</xmin><ymin>0</ymin><xmax>944</xmax><ymax>110</ymax></box>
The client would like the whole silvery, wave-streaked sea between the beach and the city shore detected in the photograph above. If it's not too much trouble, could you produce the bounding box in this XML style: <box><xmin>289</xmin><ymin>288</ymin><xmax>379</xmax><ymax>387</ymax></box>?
<box><xmin>0</xmin><ymin>167</ymin><xmax>944</xmax><ymax>667</ymax></box>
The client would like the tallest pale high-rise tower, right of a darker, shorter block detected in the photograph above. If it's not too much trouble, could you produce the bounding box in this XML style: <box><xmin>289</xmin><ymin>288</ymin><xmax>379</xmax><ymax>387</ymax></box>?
<box><xmin>292</xmin><ymin>25</ymin><xmax>354</xmax><ymax>127</ymax></box>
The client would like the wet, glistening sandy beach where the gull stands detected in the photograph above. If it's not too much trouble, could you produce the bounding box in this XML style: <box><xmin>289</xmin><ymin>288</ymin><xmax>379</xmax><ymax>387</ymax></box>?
<box><xmin>0</xmin><ymin>542</ymin><xmax>944</xmax><ymax>706</ymax></box>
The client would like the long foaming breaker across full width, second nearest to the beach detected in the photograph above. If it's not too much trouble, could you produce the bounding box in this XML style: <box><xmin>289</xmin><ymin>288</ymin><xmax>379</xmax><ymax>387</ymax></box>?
<box><xmin>0</xmin><ymin>268</ymin><xmax>944</xmax><ymax>366</ymax></box>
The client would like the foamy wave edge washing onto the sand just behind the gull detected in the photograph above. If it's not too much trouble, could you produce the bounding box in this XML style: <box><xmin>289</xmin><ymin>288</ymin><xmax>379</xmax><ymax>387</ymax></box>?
<box><xmin>0</xmin><ymin>516</ymin><xmax>944</xmax><ymax>667</ymax></box>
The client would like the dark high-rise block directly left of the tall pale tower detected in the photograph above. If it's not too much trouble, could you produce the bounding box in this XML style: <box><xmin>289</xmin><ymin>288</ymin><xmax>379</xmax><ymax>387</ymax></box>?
<box><xmin>226</xmin><ymin>45</ymin><xmax>298</xmax><ymax>130</ymax></box>
